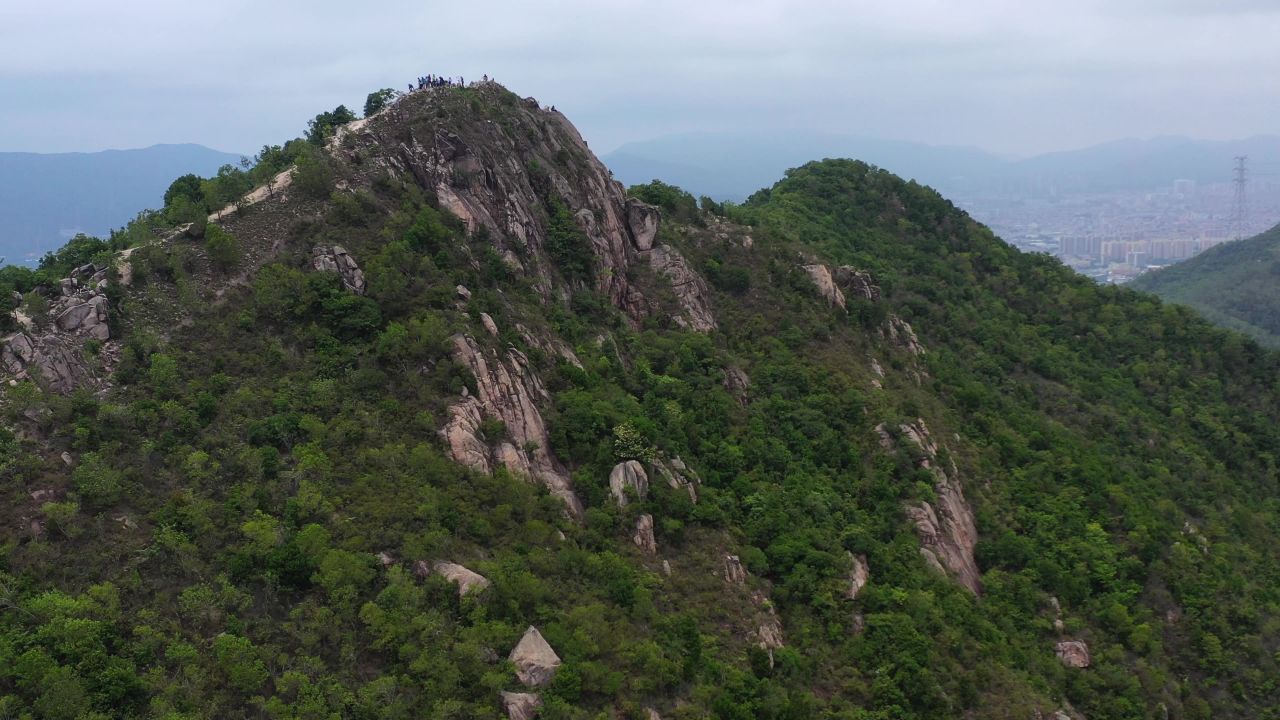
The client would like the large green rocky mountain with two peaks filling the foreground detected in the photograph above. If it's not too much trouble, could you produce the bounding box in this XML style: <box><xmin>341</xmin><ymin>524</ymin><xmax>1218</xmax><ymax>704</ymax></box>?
<box><xmin>0</xmin><ymin>83</ymin><xmax>1280</xmax><ymax>720</ymax></box>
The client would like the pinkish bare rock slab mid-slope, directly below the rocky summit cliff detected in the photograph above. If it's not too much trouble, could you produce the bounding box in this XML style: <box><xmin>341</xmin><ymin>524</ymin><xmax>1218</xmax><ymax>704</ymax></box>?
<box><xmin>440</xmin><ymin>336</ymin><xmax>582</xmax><ymax>518</ymax></box>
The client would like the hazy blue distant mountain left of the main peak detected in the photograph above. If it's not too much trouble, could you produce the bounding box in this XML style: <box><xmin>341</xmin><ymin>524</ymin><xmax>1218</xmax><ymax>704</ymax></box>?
<box><xmin>0</xmin><ymin>145</ymin><xmax>239</xmax><ymax>264</ymax></box>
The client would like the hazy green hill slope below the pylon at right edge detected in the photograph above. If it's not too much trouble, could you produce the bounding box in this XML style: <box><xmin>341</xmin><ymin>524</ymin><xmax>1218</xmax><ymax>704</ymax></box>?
<box><xmin>1133</xmin><ymin>227</ymin><xmax>1280</xmax><ymax>347</ymax></box>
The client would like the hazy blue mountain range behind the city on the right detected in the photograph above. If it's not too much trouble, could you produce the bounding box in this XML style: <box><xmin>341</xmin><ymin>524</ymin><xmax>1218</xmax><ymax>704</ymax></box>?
<box><xmin>603</xmin><ymin>132</ymin><xmax>1280</xmax><ymax>200</ymax></box>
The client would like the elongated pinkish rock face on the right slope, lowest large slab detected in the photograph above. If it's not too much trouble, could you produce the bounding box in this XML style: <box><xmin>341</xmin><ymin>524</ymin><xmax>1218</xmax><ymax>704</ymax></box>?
<box><xmin>876</xmin><ymin>418</ymin><xmax>982</xmax><ymax>593</ymax></box>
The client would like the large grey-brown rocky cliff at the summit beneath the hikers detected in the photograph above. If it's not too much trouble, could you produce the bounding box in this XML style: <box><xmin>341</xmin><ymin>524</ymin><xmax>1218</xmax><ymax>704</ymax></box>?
<box><xmin>345</xmin><ymin>83</ymin><xmax>716</xmax><ymax>331</ymax></box>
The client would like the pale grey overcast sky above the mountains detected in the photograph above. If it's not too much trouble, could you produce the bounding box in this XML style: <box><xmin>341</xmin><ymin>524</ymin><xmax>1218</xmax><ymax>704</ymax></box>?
<box><xmin>0</xmin><ymin>0</ymin><xmax>1280</xmax><ymax>155</ymax></box>
